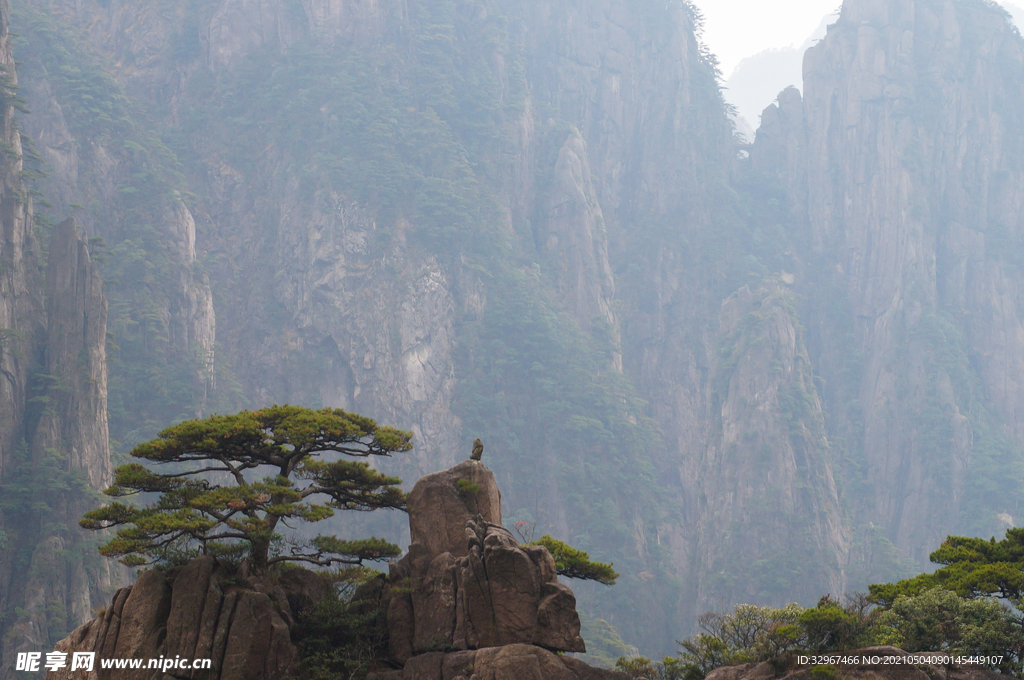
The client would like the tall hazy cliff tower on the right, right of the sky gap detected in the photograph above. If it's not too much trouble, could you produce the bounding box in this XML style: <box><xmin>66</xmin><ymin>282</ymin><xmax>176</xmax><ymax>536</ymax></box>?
<box><xmin>752</xmin><ymin>0</ymin><xmax>1024</xmax><ymax>563</ymax></box>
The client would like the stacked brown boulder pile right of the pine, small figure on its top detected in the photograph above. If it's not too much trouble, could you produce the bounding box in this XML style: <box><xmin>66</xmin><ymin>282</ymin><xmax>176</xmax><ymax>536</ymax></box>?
<box><xmin>387</xmin><ymin>461</ymin><xmax>586</xmax><ymax>664</ymax></box>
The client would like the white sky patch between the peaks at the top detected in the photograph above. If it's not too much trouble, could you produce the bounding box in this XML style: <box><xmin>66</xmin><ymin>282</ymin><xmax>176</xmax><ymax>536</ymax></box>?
<box><xmin>695</xmin><ymin>0</ymin><xmax>841</xmax><ymax>79</ymax></box>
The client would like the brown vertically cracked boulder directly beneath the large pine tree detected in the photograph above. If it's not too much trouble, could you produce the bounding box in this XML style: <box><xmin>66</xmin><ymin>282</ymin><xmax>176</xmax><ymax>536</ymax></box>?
<box><xmin>46</xmin><ymin>557</ymin><xmax>319</xmax><ymax>680</ymax></box>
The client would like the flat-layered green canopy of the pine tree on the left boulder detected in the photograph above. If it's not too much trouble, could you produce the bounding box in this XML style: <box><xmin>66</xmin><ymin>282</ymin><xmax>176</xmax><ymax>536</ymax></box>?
<box><xmin>79</xmin><ymin>406</ymin><xmax>413</xmax><ymax>569</ymax></box>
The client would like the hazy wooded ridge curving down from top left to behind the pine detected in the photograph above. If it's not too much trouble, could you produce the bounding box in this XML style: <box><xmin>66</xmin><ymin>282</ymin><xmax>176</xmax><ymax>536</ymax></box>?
<box><xmin>15</xmin><ymin>5</ymin><xmax>217</xmax><ymax>444</ymax></box>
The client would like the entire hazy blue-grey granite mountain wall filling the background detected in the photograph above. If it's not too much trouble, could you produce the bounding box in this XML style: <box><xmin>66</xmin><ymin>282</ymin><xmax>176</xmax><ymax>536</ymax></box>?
<box><xmin>6</xmin><ymin>0</ymin><xmax>1024</xmax><ymax>663</ymax></box>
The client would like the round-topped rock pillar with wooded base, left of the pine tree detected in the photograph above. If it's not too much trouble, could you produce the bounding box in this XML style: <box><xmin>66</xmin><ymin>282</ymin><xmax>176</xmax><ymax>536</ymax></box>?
<box><xmin>0</xmin><ymin>223</ymin><xmax>124</xmax><ymax>677</ymax></box>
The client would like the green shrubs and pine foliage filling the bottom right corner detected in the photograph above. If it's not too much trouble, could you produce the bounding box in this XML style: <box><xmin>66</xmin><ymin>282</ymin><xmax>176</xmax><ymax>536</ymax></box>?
<box><xmin>616</xmin><ymin>529</ymin><xmax>1024</xmax><ymax>680</ymax></box>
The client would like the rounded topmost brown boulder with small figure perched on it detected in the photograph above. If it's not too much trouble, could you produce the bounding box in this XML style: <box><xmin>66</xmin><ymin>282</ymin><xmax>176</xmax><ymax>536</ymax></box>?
<box><xmin>407</xmin><ymin>461</ymin><xmax>502</xmax><ymax>557</ymax></box>
